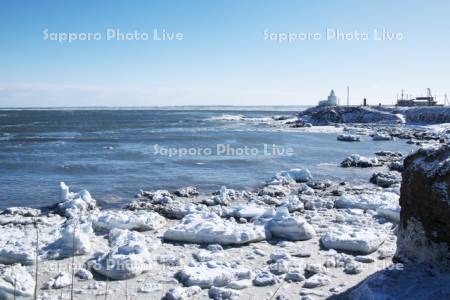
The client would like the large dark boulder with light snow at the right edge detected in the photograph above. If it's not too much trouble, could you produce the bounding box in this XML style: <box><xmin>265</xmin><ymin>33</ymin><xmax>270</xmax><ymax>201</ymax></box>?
<box><xmin>396</xmin><ymin>145</ymin><xmax>450</xmax><ymax>267</ymax></box>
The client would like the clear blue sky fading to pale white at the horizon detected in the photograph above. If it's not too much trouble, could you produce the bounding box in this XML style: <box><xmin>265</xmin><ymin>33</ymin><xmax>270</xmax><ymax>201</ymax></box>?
<box><xmin>0</xmin><ymin>0</ymin><xmax>450</xmax><ymax>107</ymax></box>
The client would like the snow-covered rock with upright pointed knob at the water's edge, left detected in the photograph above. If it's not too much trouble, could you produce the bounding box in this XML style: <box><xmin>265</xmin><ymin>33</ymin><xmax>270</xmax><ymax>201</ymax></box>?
<box><xmin>57</xmin><ymin>182</ymin><xmax>97</xmax><ymax>218</ymax></box>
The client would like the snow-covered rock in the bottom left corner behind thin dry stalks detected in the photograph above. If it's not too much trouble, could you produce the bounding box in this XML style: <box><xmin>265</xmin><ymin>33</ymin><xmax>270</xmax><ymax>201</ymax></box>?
<box><xmin>0</xmin><ymin>265</ymin><xmax>35</xmax><ymax>300</ymax></box>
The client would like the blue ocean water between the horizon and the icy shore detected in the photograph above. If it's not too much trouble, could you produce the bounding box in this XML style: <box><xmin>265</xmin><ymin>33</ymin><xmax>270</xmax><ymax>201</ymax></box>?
<box><xmin>0</xmin><ymin>107</ymin><xmax>414</xmax><ymax>209</ymax></box>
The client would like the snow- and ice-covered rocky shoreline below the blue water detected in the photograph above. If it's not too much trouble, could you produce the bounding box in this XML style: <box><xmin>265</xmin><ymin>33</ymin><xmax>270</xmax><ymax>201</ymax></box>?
<box><xmin>0</xmin><ymin>121</ymin><xmax>448</xmax><ymax>300</ymax></box>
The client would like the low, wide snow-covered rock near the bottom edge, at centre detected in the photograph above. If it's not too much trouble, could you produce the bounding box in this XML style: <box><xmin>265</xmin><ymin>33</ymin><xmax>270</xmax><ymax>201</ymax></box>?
<box><xmin>176</xmin><ymin>265</ymin><xmax>252</xmax><ymax>288</ymax></box>
